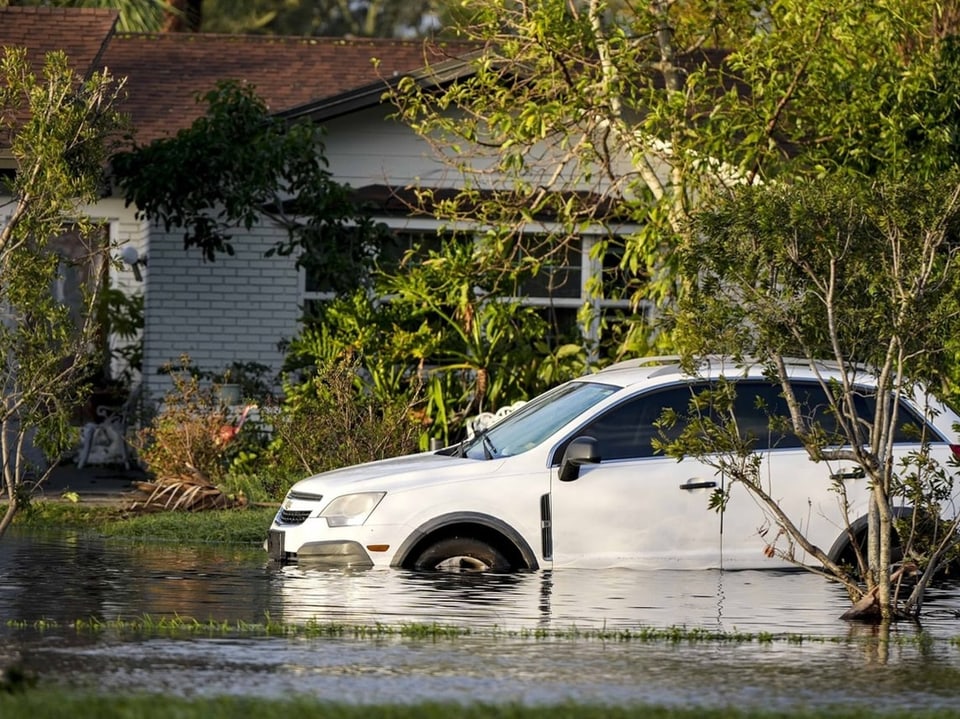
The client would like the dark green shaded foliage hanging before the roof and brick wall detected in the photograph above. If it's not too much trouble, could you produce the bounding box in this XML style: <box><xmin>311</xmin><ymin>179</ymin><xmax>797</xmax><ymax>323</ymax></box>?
<box><xmin>113</xmin><ymin>82</ymin><xmax>382</xmax><ymax>291</ymax></box>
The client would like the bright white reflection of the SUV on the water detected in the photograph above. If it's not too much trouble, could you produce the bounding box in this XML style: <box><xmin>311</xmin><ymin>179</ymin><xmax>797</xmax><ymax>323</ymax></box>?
<box><xmin>273</xmin><ymin>567</ymin><xmax>846</xmax><ymax>634</ymax></box>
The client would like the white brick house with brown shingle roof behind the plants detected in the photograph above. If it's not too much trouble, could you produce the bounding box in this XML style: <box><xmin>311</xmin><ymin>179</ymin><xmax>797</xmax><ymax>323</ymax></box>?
<box><xmin>0</xmin><ymin>7</ymin><xmax>644</xmax><ymax>420</ymax></box>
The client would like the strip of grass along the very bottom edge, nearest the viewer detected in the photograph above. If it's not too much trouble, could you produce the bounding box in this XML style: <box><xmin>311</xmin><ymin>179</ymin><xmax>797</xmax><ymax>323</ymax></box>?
<box><xmin>0</xmin><ymin>691</ymin><xmax>960</xmax><ymax>719</ymax></box>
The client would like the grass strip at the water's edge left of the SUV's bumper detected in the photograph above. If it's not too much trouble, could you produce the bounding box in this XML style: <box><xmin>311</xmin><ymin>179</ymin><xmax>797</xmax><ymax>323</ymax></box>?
<box><xmin>8</xmin><ymin>501</ymin><xmax>276</xmax><ymax>544</ymax></box>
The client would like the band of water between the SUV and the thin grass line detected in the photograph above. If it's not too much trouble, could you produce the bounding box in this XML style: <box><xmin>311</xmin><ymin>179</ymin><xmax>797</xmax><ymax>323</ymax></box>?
<box><xmin>0</xmin><ymin>534</ymin><xmax>960</xmax><ymax>636</ymax></box>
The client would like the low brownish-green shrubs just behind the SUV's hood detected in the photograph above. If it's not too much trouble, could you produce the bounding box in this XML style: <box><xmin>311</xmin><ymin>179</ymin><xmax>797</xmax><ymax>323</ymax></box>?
<box><xmin>136</xmin><ymin>360</ymin><xmax>421</xmax><ymax>502</ymax></box>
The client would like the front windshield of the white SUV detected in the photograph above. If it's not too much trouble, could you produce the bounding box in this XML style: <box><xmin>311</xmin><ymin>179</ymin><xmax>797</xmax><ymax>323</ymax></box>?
<box><xmin>459</xmin><ymin>382</ymin><xmax>620</xmax><ymax>459</ymax></box>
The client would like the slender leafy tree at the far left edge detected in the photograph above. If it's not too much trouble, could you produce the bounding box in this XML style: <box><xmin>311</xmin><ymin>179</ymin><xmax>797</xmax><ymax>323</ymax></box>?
<box><xmin>0</xmin><ymin>48</ymin><xmax>125</xmax><ymax>535</ymax></box>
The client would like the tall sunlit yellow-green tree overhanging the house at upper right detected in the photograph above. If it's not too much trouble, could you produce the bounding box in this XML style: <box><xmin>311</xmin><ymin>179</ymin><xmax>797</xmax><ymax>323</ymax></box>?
<box><xmin>394</xmin><ymin>0</ymin><xmax>957</xmax><ymax>352</ymax></box>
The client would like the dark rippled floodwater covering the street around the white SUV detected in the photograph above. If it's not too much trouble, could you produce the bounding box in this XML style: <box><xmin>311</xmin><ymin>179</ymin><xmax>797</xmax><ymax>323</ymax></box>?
<box><xmin>0</xmin><ymin>534</ymin><xmax>960</xmax><ymax>710</ymax></box>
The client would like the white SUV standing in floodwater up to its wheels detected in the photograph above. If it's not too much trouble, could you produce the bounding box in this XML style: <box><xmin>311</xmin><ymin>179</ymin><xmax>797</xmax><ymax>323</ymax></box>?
<box><xmin>266</xmin><ymin>358</ymin><xmax>960</xmax><ymax>571</ymax></box>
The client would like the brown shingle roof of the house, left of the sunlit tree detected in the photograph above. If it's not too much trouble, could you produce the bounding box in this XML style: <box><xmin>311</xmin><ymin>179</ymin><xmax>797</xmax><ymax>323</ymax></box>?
<box><xmin>0</xmin><ymin>7</ymin><xmax>464</xmax><ymax>144</ymax></box>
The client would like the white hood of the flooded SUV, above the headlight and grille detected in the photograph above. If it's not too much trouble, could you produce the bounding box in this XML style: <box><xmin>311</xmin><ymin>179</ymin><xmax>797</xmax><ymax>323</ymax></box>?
<box><xmin>284</xmin><ymin>452</ymin><xmax>480</xmax><ymax>494</ymax></box>
